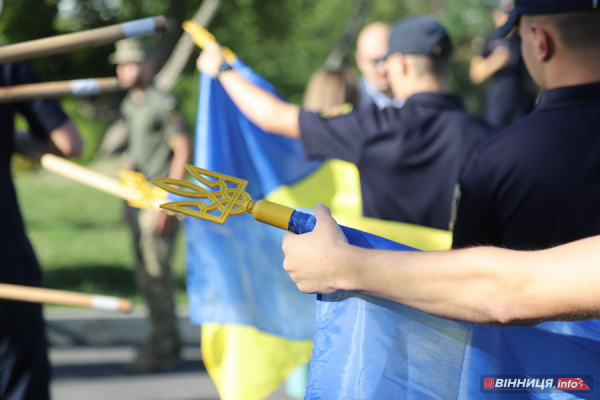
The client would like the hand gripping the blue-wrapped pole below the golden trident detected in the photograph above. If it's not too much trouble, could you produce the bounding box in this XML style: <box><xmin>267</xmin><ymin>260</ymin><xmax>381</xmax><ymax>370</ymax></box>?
<box><xmin>282</xmin><ymin>205</ymin><xmax>356</xmax><ymax>294</ymax></box>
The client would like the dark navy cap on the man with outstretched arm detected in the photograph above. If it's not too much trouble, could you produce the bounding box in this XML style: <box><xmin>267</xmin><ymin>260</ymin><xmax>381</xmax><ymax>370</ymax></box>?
<box><xmin>388</xmin><ymin>16</ymin><xmax>452</xmax><ymax>56</ymax></box>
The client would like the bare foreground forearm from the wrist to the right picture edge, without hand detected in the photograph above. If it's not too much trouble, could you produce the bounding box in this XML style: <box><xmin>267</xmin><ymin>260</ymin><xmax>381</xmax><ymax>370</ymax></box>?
<box><xmin>352</xmin><ymin>238</ymin><xmax>600</xmax><ymax>324</ymax></box>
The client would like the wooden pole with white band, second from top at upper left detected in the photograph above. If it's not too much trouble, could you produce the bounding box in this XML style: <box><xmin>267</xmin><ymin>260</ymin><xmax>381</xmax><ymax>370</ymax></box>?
<box><xmin>0</xmin><ymin>78</ymin><xmax>122</xmax><ymax>103</ymax></box>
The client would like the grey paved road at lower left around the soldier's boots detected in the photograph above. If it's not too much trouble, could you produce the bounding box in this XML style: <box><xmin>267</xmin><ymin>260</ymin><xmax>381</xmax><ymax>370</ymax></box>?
<box><xmin>45</xmin><ymin>308</ymin><xmax>290</xmax><ymax>400</ymax></box>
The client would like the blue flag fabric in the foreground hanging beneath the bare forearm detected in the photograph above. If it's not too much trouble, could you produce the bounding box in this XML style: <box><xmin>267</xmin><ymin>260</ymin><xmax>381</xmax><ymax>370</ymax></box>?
<box><xmin>305</xmin><ymin>223</ymin><xmax>600</xmax><ymax>400</ymax></box>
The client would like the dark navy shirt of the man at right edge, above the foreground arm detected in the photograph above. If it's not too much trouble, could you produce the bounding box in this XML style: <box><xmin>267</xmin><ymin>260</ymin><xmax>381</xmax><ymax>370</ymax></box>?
<box><xmin>453</xmin><ymin>82</ymin><xmax>600</xmax><ymax>250</ymax></box>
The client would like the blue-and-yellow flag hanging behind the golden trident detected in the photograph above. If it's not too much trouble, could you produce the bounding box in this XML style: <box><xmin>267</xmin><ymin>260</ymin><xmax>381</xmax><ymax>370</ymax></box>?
<box><xmin>185</xmin><ymin>60</ymin><xmax>450</xmax><ymax>400</ymax></box>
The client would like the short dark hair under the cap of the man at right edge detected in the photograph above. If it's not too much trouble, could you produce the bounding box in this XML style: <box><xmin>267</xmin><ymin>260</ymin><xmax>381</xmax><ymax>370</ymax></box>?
<box><xmin>539</xmin><ymin>11</ymin><xmax>600</xmax><ymax>50</ymax></box>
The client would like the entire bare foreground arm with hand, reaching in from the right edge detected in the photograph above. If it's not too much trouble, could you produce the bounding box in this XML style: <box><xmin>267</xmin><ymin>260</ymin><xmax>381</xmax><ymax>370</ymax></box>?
<box><xmin>283</xmin><ymin>206</ymin><xmax>600</xmax><ymax>325</ymax></box>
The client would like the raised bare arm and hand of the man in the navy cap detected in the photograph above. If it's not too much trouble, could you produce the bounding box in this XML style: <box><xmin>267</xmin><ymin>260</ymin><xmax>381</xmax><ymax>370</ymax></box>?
<box><xmin>197</xmin><ymin>42</ymin><xmax>300</xmax><ymax>138</ymax></box>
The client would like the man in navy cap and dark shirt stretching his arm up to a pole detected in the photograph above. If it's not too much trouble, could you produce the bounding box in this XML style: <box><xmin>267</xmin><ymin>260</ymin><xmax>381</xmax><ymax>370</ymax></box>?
<box><xmin>198</xmin><ymin>16</ymin><xmax>493</xmax><ymax>229</ymax></box>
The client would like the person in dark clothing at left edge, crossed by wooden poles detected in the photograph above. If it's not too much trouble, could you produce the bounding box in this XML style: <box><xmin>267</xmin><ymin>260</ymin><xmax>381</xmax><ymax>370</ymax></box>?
<box><xmin>0</xmin><ymin>63</ymin><xmax>83</xmax><ymax>400</ymax></box>
